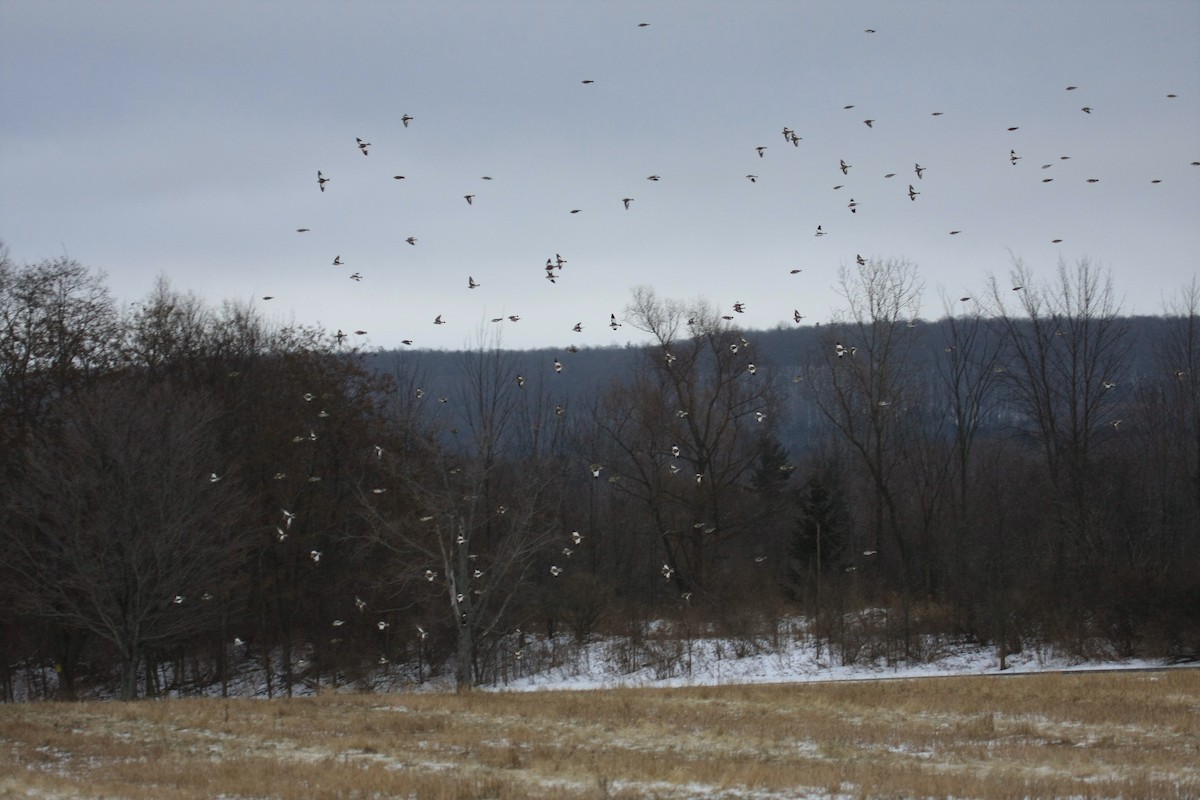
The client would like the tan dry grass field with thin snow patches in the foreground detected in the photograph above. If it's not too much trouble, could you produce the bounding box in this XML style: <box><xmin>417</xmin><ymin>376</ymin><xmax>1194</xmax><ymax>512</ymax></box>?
<box><xmin>0</xmin><ymin>669</ymin><xmax>1200</xmax><ymax>800</ymax></box>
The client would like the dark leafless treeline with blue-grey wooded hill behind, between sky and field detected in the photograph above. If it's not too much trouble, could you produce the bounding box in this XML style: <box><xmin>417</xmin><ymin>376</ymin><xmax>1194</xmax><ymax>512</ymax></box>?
<box><xmin>0</xmin><ymin>245</ymin><xmax>1200</xmax><ymax>699</ymax></box>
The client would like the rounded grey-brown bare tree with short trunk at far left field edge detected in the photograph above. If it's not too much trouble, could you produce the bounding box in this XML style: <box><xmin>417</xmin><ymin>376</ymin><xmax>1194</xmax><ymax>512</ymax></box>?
<box><xmin>6</xmin><ymin>381</ymin><xmax>252</xmax><ymax>699</ymax></box>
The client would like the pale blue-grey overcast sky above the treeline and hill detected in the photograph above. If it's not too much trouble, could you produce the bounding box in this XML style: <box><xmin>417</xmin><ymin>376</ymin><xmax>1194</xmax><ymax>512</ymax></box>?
<box><xmin>0</xmin><ymin>0</ymin><xmax>1200</xmax><ymax>348</ymax></box>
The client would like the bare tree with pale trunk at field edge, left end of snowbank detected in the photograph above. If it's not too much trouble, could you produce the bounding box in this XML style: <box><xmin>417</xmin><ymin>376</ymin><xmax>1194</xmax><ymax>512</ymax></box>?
<box><xmin>362</xmin><ymin>328</ymin><xmax>562</xmax><ymax>691</ymax></box>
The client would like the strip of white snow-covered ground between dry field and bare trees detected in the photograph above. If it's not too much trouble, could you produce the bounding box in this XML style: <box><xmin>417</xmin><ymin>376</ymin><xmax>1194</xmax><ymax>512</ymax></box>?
<box><xmin>14</xmin><ymin>620</ymin><xmax>1198</xmax><ymax>700</ymax></box>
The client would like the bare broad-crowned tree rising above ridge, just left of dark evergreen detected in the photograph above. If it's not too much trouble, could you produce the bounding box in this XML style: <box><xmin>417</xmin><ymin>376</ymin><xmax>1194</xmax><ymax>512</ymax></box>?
<box><xmin>596</xmin><ymin>287</ymin><xmax>787</xmax><ymax>599</ymax></box>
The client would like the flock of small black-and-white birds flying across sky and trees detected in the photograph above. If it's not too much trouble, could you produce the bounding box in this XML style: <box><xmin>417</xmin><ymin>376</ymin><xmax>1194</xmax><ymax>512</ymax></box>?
<box><xmin>189</xmin><ymin>23</ymin><xmax>1200</xmax><ymax>662</ymax></box>
